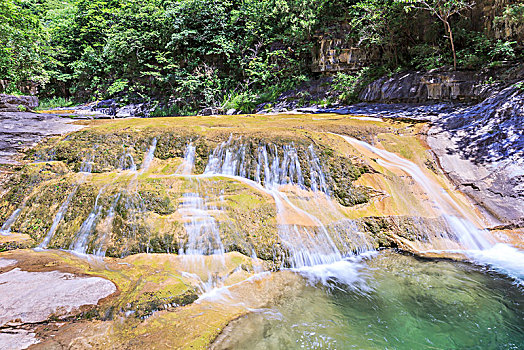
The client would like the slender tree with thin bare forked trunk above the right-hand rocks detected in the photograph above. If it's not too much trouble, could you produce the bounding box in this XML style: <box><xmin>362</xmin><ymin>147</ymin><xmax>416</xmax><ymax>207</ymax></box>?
<box><xmin>397</xmin><ymin>0</ymin><xmax>475</xmax><ymax>70</ymax></box>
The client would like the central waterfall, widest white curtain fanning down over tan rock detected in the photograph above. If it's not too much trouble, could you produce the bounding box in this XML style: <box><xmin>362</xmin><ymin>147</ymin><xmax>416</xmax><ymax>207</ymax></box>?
<box><xmin>203</xmin><ymin>137</ymin><xmax>372</xmax><ymax>268</ymax></box>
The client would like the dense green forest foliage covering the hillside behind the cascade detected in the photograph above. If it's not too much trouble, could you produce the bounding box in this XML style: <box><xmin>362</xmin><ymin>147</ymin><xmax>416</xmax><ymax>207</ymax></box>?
<box><xmin>0</xmin><ymin>0</ymin><xmax>524</xmax><ymax>113</ymax></box>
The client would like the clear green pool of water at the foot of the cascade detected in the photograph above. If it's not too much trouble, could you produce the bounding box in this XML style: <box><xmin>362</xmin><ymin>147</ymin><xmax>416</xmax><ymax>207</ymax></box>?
<box><xmin>217</xmin><ymin>253</ymin><xmax>524</xmax><ymax>350</ymax></box>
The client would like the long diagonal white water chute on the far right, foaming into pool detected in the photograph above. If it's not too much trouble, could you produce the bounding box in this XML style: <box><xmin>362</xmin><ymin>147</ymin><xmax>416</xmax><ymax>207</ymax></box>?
<box><xmin>335</xmin><ymin>134</ymin><xmax>524</xmax><ymax>280</ymax></box>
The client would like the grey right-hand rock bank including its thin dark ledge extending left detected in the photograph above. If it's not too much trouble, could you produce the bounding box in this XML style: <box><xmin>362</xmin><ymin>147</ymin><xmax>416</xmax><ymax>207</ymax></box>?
<box><xmin>286</xmin><ymin>81</ymin><xmax>524</xmax><ymax>227</ymax></box>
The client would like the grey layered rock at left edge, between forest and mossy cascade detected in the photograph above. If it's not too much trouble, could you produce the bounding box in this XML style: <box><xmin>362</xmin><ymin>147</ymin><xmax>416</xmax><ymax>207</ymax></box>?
<box><xmin>0</xmin><ymin>111</ymin><xmax>82</xmax><ymax>164</ymax></box>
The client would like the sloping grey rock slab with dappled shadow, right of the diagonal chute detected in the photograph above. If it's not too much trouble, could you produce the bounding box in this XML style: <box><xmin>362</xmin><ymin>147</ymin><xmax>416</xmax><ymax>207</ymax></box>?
<box><xmin>428</xmin><ymin>86</ymin><xmax>524</xmax><ymax>227</ymax></box>
